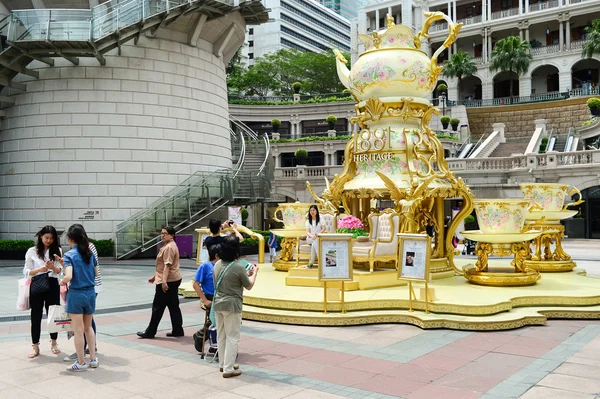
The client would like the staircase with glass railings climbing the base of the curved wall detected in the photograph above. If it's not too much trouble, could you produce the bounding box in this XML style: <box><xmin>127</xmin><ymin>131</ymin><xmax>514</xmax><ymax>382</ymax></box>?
<box><xmin>116</xmin><ymin>119</ymin><xmax>274</xmax><ymax>259</ymax></box>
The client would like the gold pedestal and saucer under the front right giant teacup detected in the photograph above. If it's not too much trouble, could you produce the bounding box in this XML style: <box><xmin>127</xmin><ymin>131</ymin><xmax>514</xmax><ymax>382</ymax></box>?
<box><xmin>461</xmin><ymin>231</ymin><xmax>542</xmax><ymax>287</ymax></box>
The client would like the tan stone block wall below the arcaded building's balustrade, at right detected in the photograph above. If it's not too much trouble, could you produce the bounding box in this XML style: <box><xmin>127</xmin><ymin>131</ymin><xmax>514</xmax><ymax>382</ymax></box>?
<box><xmin>467</xmin><ymin>98</ymin><xmax>591</xmax><ymax>141</ymax></box>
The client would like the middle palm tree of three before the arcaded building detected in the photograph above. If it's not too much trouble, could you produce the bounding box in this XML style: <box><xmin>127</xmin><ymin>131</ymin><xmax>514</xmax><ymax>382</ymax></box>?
<box><xmin>490</xmin><ymin>36</ymin><xmax>533</xmax><ymax>102</ymax></box>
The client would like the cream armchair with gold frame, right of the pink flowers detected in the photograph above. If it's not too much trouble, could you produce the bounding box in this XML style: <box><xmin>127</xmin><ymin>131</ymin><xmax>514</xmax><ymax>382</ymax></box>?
<box><xmin>352</xmin><ymin>209</ymin><xmax>400</xmax><ymax>273</ymax></box>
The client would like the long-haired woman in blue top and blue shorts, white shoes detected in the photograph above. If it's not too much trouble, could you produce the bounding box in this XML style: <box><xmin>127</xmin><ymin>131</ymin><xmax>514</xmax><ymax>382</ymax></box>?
<box><xmin>57</xmin><ymin>225</ymin><xmax>98</xmax><ymax>371</ymax></box>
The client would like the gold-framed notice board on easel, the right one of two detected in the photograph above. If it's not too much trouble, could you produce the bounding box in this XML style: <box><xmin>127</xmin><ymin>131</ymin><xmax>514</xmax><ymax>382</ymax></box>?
<box><xmin>398</xmin><ymin>233</ymin><xmax>431</xmax><ymax>282</ymax></box>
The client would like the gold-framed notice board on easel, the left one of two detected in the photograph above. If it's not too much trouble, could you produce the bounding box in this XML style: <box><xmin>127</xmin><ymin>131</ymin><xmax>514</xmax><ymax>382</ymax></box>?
<box><xmin>318</xmin><ymin>234</ymin><xmax>353</xmax><ymax>281</ymax></box>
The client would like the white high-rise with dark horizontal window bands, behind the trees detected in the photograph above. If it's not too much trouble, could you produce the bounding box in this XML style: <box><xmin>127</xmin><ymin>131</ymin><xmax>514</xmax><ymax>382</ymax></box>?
<box><xmin>242</xmin><ymin>0</ymin><xmax>351</xmax><ymax>65</ymax></box>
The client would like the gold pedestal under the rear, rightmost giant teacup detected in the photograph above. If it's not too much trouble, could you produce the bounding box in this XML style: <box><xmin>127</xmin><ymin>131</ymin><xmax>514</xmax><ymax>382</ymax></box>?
<box><xmin>525</xmin><ymin>221</ymin><xmax>577</xmax><ymax>272</ymax></box>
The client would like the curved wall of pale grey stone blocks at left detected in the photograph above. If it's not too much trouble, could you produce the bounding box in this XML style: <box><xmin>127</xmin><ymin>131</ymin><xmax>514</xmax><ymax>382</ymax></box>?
<box><xmin>0</xmin><ymin>37</ymin><xmax>231</xmax><ymax>239</ymax></box>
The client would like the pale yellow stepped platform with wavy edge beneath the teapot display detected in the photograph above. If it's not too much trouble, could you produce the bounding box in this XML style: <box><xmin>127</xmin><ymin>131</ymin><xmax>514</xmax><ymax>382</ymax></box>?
<box><xmin>180</xmin><ymin>260</ymin><xmax>600</xmax><ymax>330</ymax></box>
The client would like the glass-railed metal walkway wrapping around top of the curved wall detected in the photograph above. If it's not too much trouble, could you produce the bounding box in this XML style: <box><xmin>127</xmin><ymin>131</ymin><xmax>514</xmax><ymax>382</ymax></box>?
<box><xmin>0</xmin><ymin>0</ymin><xmax>269</xmax><ymax>93</ymax></box>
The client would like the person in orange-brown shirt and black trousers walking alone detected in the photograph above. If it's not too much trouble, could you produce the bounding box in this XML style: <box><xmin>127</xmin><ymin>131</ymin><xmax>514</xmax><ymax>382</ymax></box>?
<box><xmin>137</xmin><ymin>226</ymin><xmax>184</xmax><ymax>338</ymax></box>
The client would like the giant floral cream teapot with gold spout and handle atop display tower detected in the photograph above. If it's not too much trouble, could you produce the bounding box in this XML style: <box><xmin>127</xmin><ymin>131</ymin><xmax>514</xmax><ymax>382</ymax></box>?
<box><xmin>335</xmin><ymin>12</ymin><xmax>462</xmax><ymax>102</ymax></box>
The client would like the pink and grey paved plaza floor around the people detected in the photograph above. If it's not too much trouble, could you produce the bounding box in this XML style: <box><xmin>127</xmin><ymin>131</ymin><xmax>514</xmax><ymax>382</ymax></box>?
<box><xmin>0</xmin><ymin>240</ymin><xmax>600</xmax><ymax>399</ymax></box>
